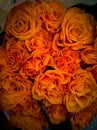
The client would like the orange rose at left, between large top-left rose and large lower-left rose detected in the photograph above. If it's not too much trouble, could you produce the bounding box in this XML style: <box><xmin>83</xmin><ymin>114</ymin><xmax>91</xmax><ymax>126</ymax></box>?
<box><xmin>2</xmin><ymin>39</ymin><xmax>29</xmax><ymax>72</ymax></box>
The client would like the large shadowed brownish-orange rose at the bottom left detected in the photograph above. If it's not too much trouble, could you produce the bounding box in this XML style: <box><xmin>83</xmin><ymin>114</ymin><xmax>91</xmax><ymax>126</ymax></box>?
<box><xmin>9</xmin><ymin>99</ymin><xmax>48</xmax><ymax>130</ymax></box>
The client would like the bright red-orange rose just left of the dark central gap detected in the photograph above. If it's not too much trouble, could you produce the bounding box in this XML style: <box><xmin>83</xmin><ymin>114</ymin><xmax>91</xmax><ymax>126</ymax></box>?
<box><xmin>19</xmin><ymin>50</ymin><xmax>52</xmax><ymax>78</ymax></box>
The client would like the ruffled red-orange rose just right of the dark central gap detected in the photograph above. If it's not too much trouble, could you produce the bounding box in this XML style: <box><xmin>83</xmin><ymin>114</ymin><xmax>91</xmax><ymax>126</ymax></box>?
<box><xmin>55</xmin><ymin>48</ymin><xmax>80</xmax><ymax>74</ymax></box>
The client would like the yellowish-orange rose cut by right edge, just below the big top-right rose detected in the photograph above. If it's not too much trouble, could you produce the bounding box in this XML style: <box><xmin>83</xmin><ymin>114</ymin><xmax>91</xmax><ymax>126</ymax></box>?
<box><xmin>81</xmin><ymin>46</ymin><xmax>97</xmax><ymax>65</ymax></box>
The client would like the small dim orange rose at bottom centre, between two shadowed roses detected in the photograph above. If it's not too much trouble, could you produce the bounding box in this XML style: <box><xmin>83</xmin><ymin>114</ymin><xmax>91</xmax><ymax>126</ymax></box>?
<box><xmin>47</xmin><ymin>104</ymin><xmax>68</xmax><ymax>125</ymax></box>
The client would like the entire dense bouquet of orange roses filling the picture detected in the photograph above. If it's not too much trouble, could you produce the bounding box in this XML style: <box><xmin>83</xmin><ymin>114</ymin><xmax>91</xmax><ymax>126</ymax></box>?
<box><xmin>0</xmin><ymin>0</ymin><xmax>97</xmax><ymax>130</ymax></box>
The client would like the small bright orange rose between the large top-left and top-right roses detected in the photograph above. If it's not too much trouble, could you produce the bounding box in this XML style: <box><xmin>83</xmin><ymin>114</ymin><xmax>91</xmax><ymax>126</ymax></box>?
<box><xmin>25</xmin><ymin>30</ymin><xmax>51</xmax><ymax>52</ymax></box>
